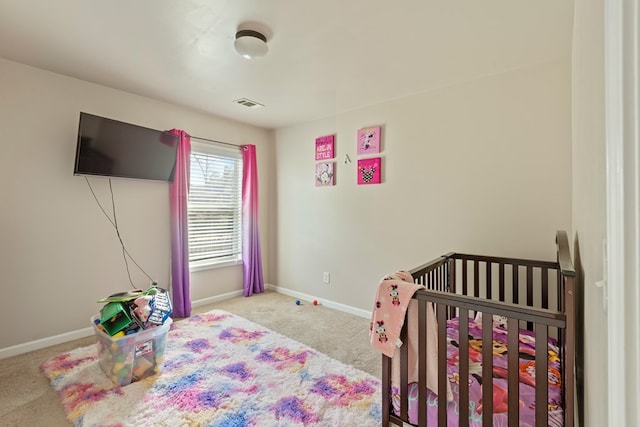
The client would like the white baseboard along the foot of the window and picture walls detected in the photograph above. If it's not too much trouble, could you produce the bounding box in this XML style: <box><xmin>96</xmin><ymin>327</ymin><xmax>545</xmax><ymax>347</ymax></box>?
<box><xmin>0</xmin><ymin>283</ymin><xmax>371</xmax><ymax>359</ymax></box>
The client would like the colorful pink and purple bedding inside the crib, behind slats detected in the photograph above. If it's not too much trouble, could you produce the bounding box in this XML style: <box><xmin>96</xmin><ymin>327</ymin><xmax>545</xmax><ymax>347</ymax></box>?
<box><xmin>391</xmin><ymin>318</ymin><xmax>563</xmax><ymax>427</ymax></box>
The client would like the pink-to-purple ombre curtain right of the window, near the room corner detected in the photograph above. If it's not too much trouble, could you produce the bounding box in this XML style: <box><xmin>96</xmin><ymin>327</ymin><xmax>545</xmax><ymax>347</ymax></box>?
<box><xmin>242</xmin><ymin>144</ymin><xmax>264</xmax><ymax>297</ymax></box>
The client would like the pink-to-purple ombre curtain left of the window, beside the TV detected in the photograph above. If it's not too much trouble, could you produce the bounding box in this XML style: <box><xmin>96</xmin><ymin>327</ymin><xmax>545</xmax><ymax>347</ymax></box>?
<box><xmin>169</xmin><ymin>129</ymin><xmax>191</xmax><ymax>318</ymax></box>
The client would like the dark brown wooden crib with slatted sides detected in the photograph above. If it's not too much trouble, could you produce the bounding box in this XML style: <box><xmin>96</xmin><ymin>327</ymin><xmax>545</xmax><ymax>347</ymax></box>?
<box><xmin>382</xmin><ymin>231</ymin><xmax>576</xmax><ymax>427</ymax></box>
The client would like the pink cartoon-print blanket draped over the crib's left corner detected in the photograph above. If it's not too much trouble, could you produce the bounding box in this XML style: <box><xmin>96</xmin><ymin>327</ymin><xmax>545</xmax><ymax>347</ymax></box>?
<box><xmin>369</xmin><ymin>271</ymin><xmax>453</xmax><ymax>400</ymax></box>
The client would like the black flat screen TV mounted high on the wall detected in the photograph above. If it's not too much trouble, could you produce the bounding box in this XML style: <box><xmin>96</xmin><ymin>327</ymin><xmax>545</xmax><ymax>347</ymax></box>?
<box><xmin>73</xmin><ymin>112</ymin><xmax>178</xmax><ymax>181</ymax></box>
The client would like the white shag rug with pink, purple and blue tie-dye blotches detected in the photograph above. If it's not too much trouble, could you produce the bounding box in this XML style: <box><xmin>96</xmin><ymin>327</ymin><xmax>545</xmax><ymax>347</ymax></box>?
<box><xmin>41</xmin><ymin>310</ymin><xmax>381</xmax><ymax>427</ymax></box>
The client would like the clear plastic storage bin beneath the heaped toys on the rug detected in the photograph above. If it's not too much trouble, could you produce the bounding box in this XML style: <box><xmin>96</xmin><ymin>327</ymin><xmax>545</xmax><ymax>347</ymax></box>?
<box><xmin>91</xmin><ymin>316</ymin><xmax>172</xmax><ymax>386</ymax></box>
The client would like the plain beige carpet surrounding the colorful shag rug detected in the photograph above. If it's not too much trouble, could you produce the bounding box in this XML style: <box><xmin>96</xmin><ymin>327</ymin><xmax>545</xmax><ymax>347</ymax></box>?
<box><xmin>0</xmin><ymin>291</ymin><xmax>381</xmax><ymax>427</ymax></box>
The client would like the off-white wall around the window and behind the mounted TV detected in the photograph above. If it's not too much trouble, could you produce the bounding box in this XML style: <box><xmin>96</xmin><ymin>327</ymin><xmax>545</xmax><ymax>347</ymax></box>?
<box><xmin>0</xmin><ymin>60</ymin><xmax>273</xmax><ymax>350</ymax></box>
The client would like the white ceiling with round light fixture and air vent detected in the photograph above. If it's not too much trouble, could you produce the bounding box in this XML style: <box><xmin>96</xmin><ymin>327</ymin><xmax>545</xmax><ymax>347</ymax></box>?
<box><xmin>0</xmin><ymin>0</ymin><xmax>573</xmax><ymax>129</ymax></box>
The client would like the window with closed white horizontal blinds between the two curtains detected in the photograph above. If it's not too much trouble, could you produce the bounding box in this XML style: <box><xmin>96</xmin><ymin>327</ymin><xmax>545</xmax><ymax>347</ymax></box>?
<box><xmin>187</xmin><ymin>141</ymin><xmax>242</xmax><ymax>269</ymax></box>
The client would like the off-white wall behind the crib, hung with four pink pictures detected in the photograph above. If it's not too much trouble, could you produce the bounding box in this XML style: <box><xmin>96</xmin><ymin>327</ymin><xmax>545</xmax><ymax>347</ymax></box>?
<box><xmin>272</xmin><ymin>58</ymin><xmax>571</xmax><ymax>310</ymax></box>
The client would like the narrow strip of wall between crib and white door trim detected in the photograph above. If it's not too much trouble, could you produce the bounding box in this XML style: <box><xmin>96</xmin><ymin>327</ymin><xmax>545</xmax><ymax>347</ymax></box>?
<box><xmin>572</xmin><ymin>0</ymin><xmax>607</xmax><ymax>426</ymax></box>
